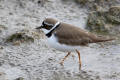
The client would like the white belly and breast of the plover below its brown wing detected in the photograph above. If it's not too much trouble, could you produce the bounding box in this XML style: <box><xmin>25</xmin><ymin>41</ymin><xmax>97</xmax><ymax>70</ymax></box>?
<box><xmin>47</xmin><ymin>35</ymin><xmax>84</xmax><ymax>52</ymax></box>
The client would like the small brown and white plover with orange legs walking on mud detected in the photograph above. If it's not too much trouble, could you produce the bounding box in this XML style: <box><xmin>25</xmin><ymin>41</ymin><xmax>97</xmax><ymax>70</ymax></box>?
<box><xmin>36</xmin><ymin>18</ymin><xmax>114</xmax><ymax>70</ymax></box>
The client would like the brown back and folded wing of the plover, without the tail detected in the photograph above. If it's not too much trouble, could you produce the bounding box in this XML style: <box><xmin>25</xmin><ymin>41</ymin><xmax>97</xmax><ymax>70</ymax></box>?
<box><xmin>55</xmin><ymin>23</ymin><xmax>96</xmax><ymax>46</ymax></box>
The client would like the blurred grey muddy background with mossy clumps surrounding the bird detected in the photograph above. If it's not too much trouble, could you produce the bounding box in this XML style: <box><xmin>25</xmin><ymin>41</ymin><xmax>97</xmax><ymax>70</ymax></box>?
<box><xmin>0</xmin><ymin>0</ymin><xmax>120</xmax><ymax>80</ymax></box>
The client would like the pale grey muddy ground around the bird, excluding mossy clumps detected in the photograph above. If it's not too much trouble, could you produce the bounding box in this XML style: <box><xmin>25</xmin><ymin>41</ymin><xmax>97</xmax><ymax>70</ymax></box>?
<box><xmin>0</xmin><ymin>0</ymin><xmax>120</xmax><ymax>80</ymax></box>
